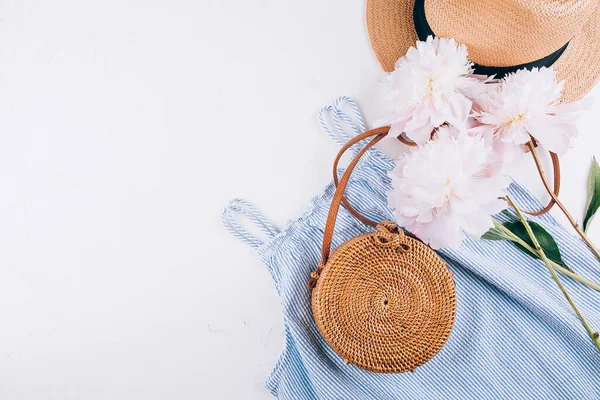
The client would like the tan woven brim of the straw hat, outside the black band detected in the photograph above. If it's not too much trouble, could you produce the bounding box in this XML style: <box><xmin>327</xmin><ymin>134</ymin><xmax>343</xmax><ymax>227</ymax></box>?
<box><xmin>366</xmin><ymin>0</ymin><xmax>600</xmax><ymax>101</ymax></box>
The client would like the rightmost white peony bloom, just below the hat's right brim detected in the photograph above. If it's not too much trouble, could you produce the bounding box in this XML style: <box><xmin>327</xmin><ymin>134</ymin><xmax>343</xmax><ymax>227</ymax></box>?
<box><xmin>478</xmin><ymin>68</ymin><xmax>587</xmax><ymax>158</ymax></box>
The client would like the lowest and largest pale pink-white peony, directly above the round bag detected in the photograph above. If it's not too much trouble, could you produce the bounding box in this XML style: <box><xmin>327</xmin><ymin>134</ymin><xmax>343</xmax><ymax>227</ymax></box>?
<box><xmin>388</xmin><ymin>126</ymin><xmax>509</xmax><ymax>249</ymax></box>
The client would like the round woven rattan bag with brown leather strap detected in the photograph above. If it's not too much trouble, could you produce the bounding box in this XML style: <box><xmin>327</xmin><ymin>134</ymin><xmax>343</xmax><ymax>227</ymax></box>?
<box><xmin>309</xmin><ymin>128</ymin><xmax>456</xmax><ymax>373</ymax></box>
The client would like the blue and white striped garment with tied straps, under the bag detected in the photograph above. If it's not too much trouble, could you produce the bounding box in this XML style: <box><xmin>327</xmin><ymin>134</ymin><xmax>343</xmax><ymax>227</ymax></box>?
<box><xmin>224</xmin><ymin>97</ymin><xmax>600</xmax><ymax>400</ymax></box>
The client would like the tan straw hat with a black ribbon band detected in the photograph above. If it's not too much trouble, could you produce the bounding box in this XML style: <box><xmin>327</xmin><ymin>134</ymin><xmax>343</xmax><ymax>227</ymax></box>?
<box><xmin>366</xmin><ymin>0</ymin><xmax>600</xmax><ymax>101</ymax></box>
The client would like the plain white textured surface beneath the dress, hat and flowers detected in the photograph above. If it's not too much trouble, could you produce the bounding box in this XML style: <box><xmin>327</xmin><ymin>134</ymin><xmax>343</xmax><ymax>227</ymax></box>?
<box><xmin>0</xmin><ymin>0</ymin><xmax>600</xmax><ymax>400</ymax></box>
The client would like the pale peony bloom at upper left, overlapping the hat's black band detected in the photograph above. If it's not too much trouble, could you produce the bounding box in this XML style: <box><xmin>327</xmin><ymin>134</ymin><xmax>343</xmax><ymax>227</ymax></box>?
<box><xmin>380</xmin><ymin>37</ymin><xmax>491</xmax><ymax>144</ymax></box>
